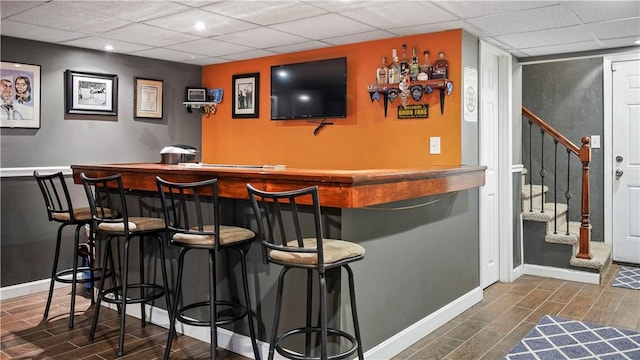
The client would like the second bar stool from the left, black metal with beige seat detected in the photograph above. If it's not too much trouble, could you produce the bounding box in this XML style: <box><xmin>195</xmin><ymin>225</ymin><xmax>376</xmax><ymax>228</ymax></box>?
<box><xmin>80</xmin><ymin>173</ymin><xmax>171</xmax><ymax>356</ymax></box>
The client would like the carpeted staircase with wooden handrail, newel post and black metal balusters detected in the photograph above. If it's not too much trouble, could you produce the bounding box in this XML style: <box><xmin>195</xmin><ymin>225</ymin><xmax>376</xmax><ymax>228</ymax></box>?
<box><xmin>521</xmin><ymin>107</ymin><xmax>611</xmax><ymax>282</ymax></box>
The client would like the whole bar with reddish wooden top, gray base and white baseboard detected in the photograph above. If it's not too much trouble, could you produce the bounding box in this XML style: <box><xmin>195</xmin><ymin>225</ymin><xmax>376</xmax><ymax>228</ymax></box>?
<box><xmin>71</xmin><ymin>163</ymin><xmax>486</xmax><ymax>359</ymax></box>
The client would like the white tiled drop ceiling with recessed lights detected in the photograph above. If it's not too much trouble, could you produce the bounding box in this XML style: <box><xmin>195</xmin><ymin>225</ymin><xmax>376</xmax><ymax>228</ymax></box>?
<box><xmin>0</xmin><ymin>0</ymin><xmax>640</xmax><ymax>65</ymax></box>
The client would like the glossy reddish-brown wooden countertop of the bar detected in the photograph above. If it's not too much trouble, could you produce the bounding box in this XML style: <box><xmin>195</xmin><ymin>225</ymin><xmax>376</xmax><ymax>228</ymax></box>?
<box><xmin>71</xmin><ymin>163</ymin><xmax>486</xmax><ymax>208</ymax></box>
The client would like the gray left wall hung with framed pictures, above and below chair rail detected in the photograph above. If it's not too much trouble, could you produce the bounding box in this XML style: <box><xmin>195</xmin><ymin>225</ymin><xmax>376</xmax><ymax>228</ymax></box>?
<box><xmin>0</xmin><ymin>37</ymin><xmax>202</xmax><ymax>286</ymax></box>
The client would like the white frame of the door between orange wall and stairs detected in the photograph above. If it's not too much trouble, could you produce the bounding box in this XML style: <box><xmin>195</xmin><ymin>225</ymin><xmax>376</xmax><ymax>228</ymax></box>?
<box><xmin>478</xmin><ymin>40</ymin><xmax>515</xmax><ymax>284</ymax></box>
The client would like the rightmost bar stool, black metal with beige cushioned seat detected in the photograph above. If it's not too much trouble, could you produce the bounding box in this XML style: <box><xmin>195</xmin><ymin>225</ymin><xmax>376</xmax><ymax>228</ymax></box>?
<box><xmin>247</xmin><ymin>184</ymin><xmax>365</xmax><ymax>360</ymax></box>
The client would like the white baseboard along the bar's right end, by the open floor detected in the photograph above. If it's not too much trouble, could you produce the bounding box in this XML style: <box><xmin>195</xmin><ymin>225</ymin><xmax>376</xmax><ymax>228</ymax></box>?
<box><xmin>364</xmin><ymin>287</ymin><xmax>482</xmax><ymax>359</ymax></box>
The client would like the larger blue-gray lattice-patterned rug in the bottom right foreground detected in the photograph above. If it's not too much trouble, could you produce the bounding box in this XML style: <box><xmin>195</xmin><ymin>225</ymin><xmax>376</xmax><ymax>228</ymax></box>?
<box><xmin>504</xmin><ymin>315</ymin><xmax>640</xmax><ymax>360</ymax></box>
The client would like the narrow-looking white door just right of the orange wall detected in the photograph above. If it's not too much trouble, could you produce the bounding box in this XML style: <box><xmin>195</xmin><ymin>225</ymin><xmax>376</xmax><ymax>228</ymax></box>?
<box><xmin>479</xmin><ymin>46</ymin><xmax>502</xmax><ymax>289</ymax></box>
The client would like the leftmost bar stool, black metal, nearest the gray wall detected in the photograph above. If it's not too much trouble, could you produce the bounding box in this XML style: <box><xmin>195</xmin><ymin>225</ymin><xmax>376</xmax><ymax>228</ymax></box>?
<box><xmin>33</xmin><ymin>170</ymin><xmax>105</xmax><ymax>328</ymax></box>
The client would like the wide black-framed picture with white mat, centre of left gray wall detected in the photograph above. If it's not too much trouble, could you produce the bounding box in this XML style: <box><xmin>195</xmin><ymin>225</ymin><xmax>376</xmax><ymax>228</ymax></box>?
<box><xmin>65</xmin><ymin>70</ymin><xmax>118</xmax><ymax>115</ymax></box>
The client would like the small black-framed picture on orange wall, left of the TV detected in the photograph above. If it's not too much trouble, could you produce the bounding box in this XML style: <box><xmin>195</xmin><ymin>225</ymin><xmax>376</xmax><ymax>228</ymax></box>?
<box><xmin>231</xmin><ymin>73</ymin><xmax>260</xmax><ymax>118</ymax></box>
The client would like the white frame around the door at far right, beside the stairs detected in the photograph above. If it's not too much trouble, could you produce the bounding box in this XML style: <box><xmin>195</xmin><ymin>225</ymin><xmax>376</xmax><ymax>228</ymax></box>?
<box><xmin>602</xmin><ymin>51</ymin><xmax>640</xmax><ymax>252</ymax></box>
